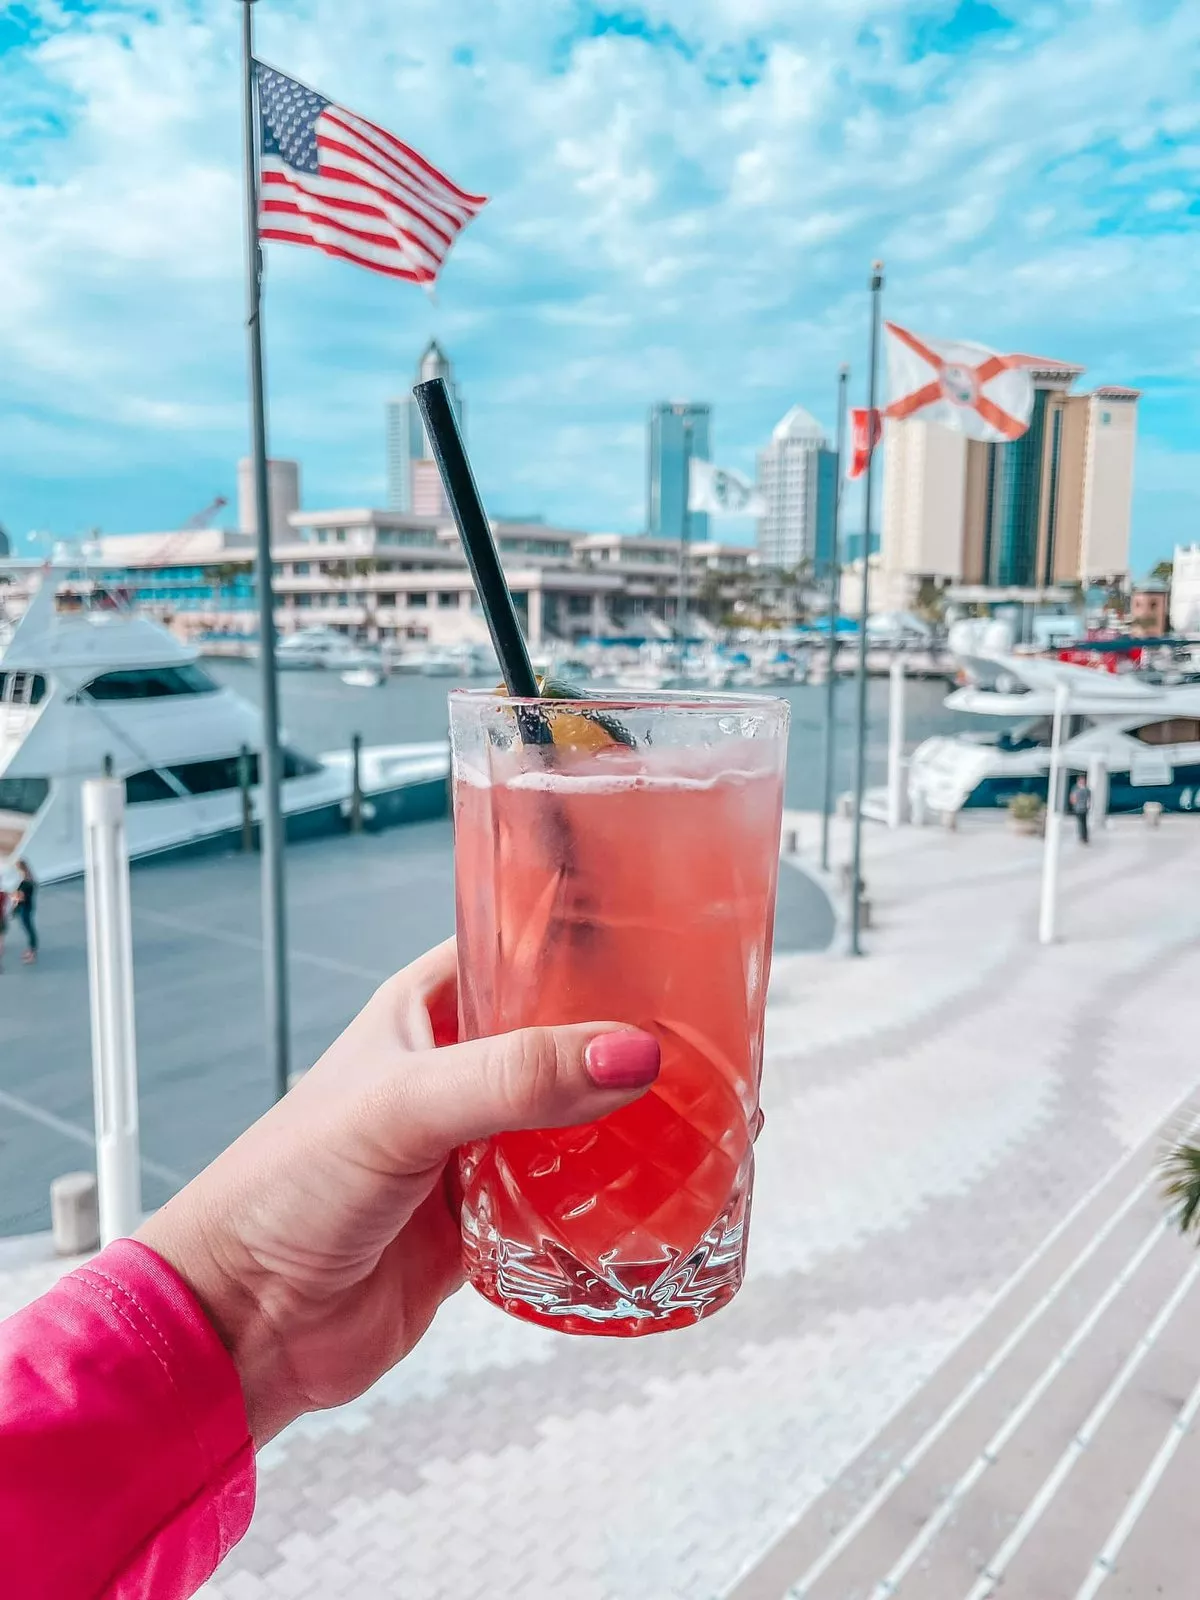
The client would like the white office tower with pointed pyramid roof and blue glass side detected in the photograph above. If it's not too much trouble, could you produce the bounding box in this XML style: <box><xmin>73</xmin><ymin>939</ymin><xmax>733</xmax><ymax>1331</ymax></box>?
<box><xmin>758</xmin><ymin>405</ymin><xmax>837</xmax><ymax>578</ymax></box>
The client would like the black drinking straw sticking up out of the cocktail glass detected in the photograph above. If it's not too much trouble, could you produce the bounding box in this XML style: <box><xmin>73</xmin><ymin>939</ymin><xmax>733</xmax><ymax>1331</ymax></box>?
<box><xmin>413</xmin><ymin>378</ymin><xmax>538</xmax><ymax>699</ymax></box>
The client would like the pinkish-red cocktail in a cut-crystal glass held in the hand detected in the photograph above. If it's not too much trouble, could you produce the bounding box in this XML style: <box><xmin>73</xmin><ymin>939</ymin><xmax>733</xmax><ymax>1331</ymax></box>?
<box><xmin>451</xmin><ymin>693</ymin><xmax>787</xmax><ymax>1334</ymax></box>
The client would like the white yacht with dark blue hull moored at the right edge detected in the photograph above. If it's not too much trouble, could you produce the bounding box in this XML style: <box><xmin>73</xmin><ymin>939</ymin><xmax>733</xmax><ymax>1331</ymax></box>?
<box><xmin>909</xmin><ymin>656</ymin><xmax>1200</xmax><ymax>813</ymax></box>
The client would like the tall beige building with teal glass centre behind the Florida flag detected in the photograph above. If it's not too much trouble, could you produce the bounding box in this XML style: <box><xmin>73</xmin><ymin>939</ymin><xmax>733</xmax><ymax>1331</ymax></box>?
<box><xmin>878</xmin><ymin>362</ymin><xmax>1139</xmax><ymax>610</ymax></box>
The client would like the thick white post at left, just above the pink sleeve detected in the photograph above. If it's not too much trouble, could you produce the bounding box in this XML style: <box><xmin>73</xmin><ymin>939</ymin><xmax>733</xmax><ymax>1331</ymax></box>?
<box><xmin>83</xmin><ymin>778</ymin><xmax>142</xmax><ymax>1245</ymax></box>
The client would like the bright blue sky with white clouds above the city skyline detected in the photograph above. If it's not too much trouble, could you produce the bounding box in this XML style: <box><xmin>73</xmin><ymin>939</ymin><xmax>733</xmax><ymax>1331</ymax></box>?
<box><xmin>0</xmin><ymin>0</ymin><xmax>1200</xmax><ymax>566</ymax></box>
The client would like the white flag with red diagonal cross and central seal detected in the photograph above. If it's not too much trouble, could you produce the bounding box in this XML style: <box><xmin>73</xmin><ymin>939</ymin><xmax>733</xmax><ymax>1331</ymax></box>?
<box><xmin>883</xmin><ymin>322</ymin><xmax>1037</xmax><ymax>445</ymax></box>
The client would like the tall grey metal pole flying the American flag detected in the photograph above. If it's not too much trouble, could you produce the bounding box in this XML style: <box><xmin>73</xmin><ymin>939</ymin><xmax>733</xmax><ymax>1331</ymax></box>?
<box><xmin>242</xmin><ymin>0</ymin><xmax>290</xmax><ymax>1099</ymax></box>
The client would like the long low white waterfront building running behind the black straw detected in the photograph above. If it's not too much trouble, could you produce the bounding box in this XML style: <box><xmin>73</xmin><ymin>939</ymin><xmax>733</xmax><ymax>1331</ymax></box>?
<box><xmin>18</xmin><ymin>507</ymin><xmax>765</xmax><ymax>648</ymax></box>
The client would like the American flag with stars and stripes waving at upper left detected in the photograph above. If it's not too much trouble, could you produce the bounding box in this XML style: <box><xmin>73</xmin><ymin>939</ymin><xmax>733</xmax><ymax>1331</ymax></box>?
<box><xmin>254</xmin><ymin>61</ymin><xmax>486</xmax><ymax>283</ymax></box>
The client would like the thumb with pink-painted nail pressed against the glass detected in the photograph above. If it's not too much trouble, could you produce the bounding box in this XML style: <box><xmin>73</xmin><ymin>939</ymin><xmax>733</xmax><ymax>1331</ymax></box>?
<box><xmin>381</xmin><ymin>1022</ymin><xmax>659</xmax><ymax>1166</ymax></box>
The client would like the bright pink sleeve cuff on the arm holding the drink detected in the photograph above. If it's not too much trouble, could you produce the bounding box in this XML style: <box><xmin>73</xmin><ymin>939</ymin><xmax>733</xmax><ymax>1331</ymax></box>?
<box><xmin>0</xmin><ymin>1238</ymin><xmax>254</xmax><ymax>1600</ymax></box>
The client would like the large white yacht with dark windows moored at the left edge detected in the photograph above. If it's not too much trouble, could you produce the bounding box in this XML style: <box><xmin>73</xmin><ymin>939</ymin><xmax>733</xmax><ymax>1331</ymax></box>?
<box><xmin>0</xmin><ymin>573</ymin><xmax>450</xmax><ymax>880</ymax></box>
